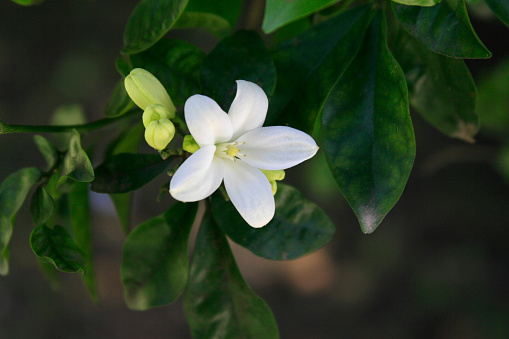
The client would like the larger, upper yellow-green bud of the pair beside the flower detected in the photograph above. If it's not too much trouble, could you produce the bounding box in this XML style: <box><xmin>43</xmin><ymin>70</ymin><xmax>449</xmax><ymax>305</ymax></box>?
<box><xmin>124</xmin><ymin>68</ymin><xmax>177</xmax><ymax>118</ymax></box>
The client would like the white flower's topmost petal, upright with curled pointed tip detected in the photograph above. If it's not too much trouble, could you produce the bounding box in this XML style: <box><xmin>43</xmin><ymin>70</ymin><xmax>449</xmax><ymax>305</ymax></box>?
<box><xmin>228</xmin><ymin>80</ymin><xmax>269</xmax><ymax>140</ymax></box>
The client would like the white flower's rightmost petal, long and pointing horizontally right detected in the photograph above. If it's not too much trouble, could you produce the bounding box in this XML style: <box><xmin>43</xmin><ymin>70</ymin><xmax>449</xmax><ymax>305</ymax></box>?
<box><xmin>236</xmin><ymin>126</ymin><xmax>318</xmax><ymax>170</ymax></box>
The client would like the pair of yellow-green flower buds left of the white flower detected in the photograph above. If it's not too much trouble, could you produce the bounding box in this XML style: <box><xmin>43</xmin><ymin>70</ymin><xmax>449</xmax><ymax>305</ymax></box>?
<box><xmin>125</xmin><ymin>68</ymin><xmax>176</xmax><ymax>151</ymax></box>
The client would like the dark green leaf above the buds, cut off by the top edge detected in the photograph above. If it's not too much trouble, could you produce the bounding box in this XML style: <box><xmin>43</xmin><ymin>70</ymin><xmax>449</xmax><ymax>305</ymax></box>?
<box><xmin>122</xmin><ymin>0</ymin><xmax>188</xmax><ymax>54</ymax></box>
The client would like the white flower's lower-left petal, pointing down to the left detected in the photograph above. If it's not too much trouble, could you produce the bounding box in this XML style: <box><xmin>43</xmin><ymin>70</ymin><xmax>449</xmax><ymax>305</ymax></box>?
<box><xmin>170</xmin><ymin>146</ymin><xmax>224</xmax><ymax>202</ymax></box>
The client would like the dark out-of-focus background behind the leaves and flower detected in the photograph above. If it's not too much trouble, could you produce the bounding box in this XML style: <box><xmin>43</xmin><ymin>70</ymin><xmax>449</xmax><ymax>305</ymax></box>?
<box><xmin>0</xmin><ymin>0</ymin><xmax>509</xmax><ymax>339</ymax></box>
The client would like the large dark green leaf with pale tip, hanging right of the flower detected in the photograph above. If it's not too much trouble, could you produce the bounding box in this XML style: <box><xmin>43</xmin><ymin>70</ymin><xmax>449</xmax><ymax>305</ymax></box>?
<box><xmin>322</xmin><ymin>12</ymin><xmax>415</xmax><ymax>233</ymax></box>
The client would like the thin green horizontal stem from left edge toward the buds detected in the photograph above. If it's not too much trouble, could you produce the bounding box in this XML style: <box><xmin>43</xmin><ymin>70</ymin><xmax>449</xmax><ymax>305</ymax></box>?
<box><xmin>0</xmin><ymin>110</ymin><xmax>139</xmax><ymax>135</ymax></box>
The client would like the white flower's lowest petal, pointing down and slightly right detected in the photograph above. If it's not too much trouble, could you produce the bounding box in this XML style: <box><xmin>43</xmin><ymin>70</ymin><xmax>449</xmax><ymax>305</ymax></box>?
<box><xmin>219</xmin><ymin>158</ymin><xmax>276</xmax><ymax>228</ymax></box>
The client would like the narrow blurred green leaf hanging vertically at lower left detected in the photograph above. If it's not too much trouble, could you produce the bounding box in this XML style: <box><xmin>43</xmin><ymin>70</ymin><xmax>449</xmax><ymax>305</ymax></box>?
<box><xmin>69</xmin><ymin>182</ymin><xmax>98</xmax><ymax>301</ymax></box>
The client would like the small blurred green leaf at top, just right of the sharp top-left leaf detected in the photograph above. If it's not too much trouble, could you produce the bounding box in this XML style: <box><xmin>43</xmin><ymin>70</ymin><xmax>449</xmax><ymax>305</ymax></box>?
<box><xmin>173</xmin><ymin>11</ymin><xmax>231</xmax><ymax>38</ymax></box>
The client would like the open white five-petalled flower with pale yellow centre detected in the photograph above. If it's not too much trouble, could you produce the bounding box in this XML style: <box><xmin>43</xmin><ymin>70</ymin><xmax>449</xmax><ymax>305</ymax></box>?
<box><xmin>170</xmin><ymin>80</ymin><xmax>318</xmax><ymax>227</ymax></box>
